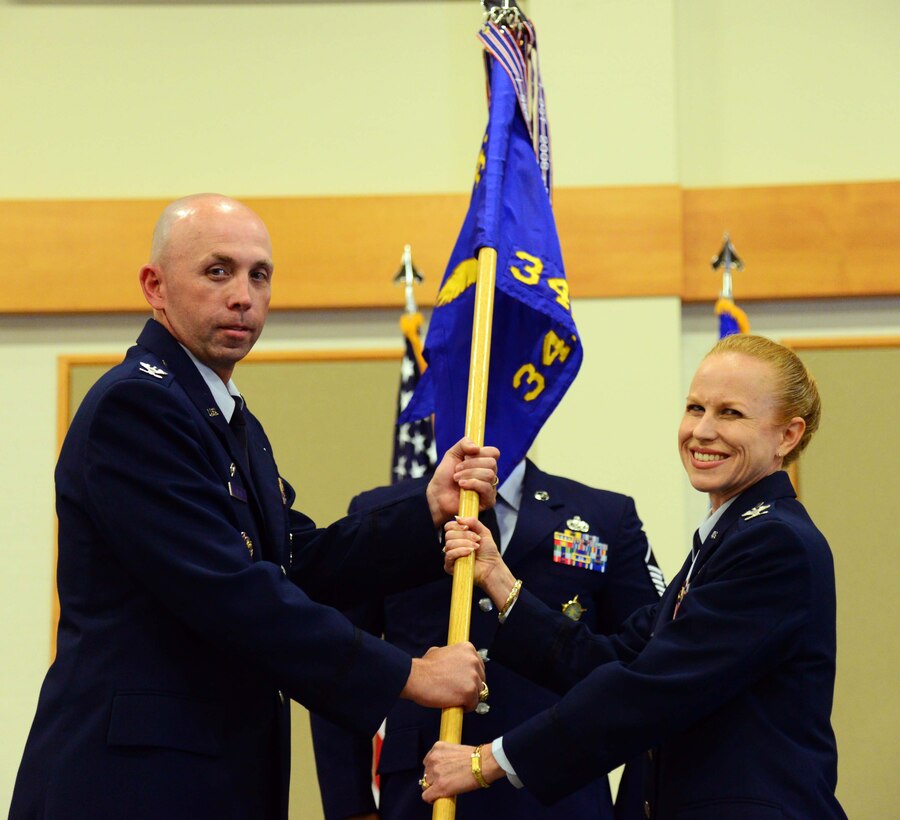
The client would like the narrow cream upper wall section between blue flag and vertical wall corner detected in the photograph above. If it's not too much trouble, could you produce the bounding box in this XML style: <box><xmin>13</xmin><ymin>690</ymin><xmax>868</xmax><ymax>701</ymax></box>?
<box><xmin>520</xmin><ymin>0</ymin><xmax>678</xmax><ymax>186</ymax></box>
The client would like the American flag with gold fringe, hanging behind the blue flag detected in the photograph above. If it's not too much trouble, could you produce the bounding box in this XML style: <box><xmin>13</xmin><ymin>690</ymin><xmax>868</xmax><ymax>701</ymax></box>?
<box><xmin>391</xmin><ymin>312</ymin><xmax>437</xmax><ymax>484</ymax></box>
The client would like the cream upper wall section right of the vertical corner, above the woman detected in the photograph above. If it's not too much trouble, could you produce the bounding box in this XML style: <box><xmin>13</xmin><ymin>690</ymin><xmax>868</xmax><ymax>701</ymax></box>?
<box><xmin>673</xmin><ymin>0</ymin><xmax>900</xmax><ymax>186</ymax></box>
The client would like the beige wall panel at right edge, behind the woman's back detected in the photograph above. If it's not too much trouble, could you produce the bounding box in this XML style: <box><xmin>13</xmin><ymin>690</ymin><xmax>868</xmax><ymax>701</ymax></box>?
<box><xmin>795</xmin><ymin>337</ymin><xmax>900</xmax><ymax>817</ymax></box>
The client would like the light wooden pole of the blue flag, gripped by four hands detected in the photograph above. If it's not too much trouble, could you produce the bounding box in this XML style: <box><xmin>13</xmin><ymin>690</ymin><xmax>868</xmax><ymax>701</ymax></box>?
<box><xmin>431</xmin><ymin>243</ymin><xmax>497</xmax><ymax>820</ymax></box>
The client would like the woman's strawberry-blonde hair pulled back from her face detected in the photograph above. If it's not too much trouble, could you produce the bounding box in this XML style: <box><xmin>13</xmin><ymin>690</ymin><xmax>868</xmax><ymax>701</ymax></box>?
<box><xmin>706</xmin><ymin>333</ymin><xmax>822</xmax><ymax>466</ymax></box>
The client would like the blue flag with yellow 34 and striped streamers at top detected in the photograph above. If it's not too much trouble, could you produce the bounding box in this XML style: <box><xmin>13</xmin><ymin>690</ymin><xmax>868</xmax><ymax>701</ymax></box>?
<box><xmin>400</xmin><ymin>21</ymin><xmax>582</xmax><ymax>482</ymax></box>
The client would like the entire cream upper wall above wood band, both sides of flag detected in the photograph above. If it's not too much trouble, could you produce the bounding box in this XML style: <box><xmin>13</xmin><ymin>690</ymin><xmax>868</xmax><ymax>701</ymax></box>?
<box><xmin>0</xmin><ymin>0</ymin><xmax>900</xmax><ymax>198</ymax></box>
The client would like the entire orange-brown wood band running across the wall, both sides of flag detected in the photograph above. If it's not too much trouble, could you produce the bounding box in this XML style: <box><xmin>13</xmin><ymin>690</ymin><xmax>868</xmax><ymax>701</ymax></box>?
<box><xmin>0</xmin><ymin>182</ymin><xmax>900</xmax><ymax>314</ymax></box>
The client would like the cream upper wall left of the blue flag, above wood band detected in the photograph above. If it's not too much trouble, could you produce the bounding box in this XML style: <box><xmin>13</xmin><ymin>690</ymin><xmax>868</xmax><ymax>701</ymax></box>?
<box><xmin>0</xmin><ymin>0</ymin><xmax>485</xmax><ymax>197</ymax></box>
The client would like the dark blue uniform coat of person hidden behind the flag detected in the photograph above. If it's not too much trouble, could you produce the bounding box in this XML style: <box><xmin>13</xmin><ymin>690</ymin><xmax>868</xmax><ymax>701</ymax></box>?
<box><xmin>312</xmin><ymin>462</ymin><xmax>661</xmax><ymax>820</ymax></box>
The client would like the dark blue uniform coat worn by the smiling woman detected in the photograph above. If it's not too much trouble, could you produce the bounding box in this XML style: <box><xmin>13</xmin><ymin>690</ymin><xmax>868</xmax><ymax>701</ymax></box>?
<box><xmin>491</xmin><ymin>471</ymin><xmax>845</xmax><ymax>820</ymax></box>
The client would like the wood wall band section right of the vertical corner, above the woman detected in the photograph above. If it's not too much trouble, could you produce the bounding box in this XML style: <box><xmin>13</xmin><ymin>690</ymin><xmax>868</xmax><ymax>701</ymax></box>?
<box><xmin>681</xmin><ymin>182</ymin><xmax>900</xmax><ymax>301</ymax></box>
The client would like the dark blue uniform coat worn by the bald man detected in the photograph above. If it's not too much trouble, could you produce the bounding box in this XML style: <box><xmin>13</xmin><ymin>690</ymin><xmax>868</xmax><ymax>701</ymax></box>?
<box><xmin>10</xmin><ymin>320</ymin><xmax>442</xmax><ymax>820</ymax></box>
